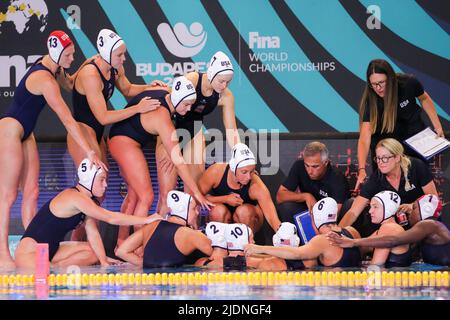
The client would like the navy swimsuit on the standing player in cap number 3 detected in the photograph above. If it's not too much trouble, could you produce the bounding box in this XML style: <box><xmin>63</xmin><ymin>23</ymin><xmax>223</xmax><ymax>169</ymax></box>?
<box><xmin>72</xmin><ymin>61</ymin><xmax>116</xmax><ymax>143</ymax></box>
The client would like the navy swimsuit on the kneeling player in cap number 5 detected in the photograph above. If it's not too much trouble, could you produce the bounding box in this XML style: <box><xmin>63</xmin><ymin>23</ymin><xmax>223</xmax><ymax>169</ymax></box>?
<box><xmin>22</xmin><ymin>190</ymin><xmax>85</xmax><ymax>261</ymax></box>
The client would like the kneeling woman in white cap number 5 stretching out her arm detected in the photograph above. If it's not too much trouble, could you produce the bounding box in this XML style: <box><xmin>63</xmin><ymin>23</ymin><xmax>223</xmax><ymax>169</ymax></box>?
<box><xmin>15</xmin><ymin>159</ymin><xmax>161</xmax><ymax>270</ymax></box>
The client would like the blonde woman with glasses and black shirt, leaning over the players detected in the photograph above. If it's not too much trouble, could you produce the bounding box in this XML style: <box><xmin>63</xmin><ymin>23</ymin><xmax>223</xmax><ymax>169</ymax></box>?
<box><xmin>339</xmin><ymin>138</ymin><xmax>438</xmax><ymax>237</ymax></box>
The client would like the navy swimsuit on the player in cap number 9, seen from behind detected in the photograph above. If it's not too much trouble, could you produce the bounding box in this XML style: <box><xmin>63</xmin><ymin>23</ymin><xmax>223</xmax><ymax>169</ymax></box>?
<box><xmin>143</xmin><ymin>221</ymin><xmax>187</xmax><ymax>268</ymax></box>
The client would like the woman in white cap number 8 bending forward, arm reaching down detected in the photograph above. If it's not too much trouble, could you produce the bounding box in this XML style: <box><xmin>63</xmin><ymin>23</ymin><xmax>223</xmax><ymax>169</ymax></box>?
<box><xmin>108</xmin><ymin>76</ymin><xmax>214</xmax><ymax>249</ymax></box>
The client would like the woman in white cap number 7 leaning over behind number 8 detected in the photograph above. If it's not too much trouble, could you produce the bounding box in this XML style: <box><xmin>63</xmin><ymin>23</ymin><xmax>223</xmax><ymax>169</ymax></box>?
<box><xmin>156</xmin><ymin>51</ymin><xmax>240</xmax><ymax>213</ymax></box>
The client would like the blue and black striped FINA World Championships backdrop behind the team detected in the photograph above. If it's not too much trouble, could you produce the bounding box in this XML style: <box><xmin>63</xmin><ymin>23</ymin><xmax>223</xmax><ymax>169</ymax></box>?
<box><xmin>0</xmin><ymin>0</ymin><xmax>450</xmax><ymax>234</ymax></box>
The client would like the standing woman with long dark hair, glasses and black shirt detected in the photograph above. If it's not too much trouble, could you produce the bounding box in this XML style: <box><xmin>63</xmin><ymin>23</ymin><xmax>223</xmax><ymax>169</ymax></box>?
<box><xmin>355</xmin><ymin>59</ymin><xmax>444</xmax><ymax>190</ymax></box>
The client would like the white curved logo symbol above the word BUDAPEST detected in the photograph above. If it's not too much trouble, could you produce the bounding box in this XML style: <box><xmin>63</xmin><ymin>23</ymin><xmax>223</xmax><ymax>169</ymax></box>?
<box><xmin>157</xmin><ymin>22</ymin><xmax>207</xmax><ymax>58</ymax></box>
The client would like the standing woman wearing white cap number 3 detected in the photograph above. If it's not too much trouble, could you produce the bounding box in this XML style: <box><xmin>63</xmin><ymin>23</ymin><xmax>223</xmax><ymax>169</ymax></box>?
<box><xmin>67</xmin><ymin>29</ymin><xmax>162</xmax><ymax>240</ymax></box>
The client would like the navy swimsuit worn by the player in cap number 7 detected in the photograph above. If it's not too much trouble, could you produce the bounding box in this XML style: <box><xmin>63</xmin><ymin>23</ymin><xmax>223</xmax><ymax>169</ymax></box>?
<box><xmin>175</xmin><ymin>72</ymin><xmax>220</xmax><ymax>139</ymax></box>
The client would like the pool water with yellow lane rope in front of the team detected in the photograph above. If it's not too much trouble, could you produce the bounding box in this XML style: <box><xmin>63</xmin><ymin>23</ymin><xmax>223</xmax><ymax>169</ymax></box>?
<box><xmin>0</xmin><ymin>263</ymin><xmax>450</xmax><ymax>300</ymax></box>
